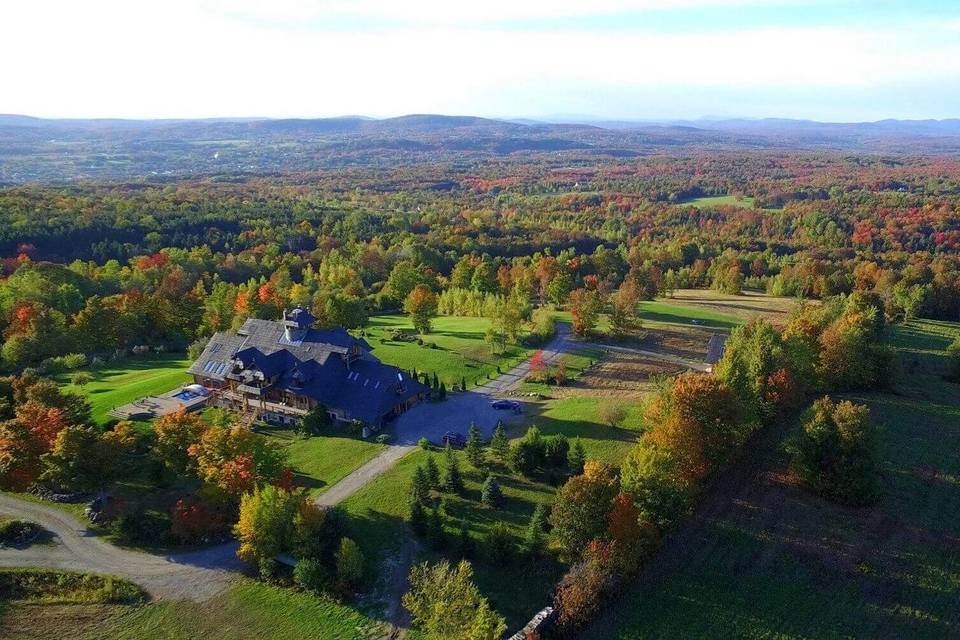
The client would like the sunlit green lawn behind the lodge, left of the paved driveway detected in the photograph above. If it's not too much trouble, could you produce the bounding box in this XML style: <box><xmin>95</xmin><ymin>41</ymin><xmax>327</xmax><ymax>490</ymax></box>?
<box><xmin>363</xmin><ymin>315</ymin><xmax>533</xmax><ymax>389</ymax></box>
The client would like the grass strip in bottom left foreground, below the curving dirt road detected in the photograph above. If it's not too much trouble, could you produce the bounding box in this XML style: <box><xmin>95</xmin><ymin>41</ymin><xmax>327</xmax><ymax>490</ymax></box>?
<box><xmin>0</xmin><ymin>580</ymin><xmax>386</xmax><ymax>640</ymax></box>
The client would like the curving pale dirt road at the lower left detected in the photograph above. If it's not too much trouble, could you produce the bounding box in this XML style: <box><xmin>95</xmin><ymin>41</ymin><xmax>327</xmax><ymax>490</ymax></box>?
<box><xmin>0</xmin><ymin>494</ymin><xmax>245</xmax><ymax>601</ymax></box>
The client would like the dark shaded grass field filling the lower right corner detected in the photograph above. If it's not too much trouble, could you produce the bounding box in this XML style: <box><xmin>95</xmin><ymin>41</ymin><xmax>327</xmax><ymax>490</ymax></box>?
<box><xmin>584</xmin><ymin>322</ymin><xmax>960</xmax><ymax>640</ymax></box>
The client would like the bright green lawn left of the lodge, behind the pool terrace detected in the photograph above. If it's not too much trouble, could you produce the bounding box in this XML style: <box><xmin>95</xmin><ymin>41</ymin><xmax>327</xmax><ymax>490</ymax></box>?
<box><xmin>57</xmin><ymin>353</ymin><xmax>192</xmax><ymax>424</ymax></box>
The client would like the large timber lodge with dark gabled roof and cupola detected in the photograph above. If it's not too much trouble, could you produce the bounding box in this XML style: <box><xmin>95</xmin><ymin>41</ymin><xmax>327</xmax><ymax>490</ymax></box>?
<box><xmin>188</xmin><ymin>308</ymin><xmax>430</xmax><ymax>429</ymax></box>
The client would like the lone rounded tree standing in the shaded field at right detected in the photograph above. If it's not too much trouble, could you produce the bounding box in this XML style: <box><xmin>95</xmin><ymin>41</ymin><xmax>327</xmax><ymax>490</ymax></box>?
<box><xmin>788</xmin><ymin>397</ymin><xmax>878</xmax><ymax>505</ymax></box>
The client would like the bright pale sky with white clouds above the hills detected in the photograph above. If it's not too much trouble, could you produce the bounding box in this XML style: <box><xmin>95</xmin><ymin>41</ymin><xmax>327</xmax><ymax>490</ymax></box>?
<box><xmin>0</xmin><ymin>0</ymin><xmax>960</xmax><ymax>121</ymax></box>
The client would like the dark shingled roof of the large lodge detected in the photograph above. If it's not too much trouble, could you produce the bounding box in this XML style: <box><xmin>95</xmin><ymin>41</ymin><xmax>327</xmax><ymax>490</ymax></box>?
<box><xmin>188</xmin><ymin>318</ymin><xmax>429</xmax><ymax>423</ymax></box>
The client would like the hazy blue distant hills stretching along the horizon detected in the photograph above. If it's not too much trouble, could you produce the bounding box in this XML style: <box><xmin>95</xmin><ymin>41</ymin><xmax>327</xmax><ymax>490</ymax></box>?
<box><xmin>0</xmin><ymin>114</ymin><xmax>960</xmax><ymax>184</ymax></box>
